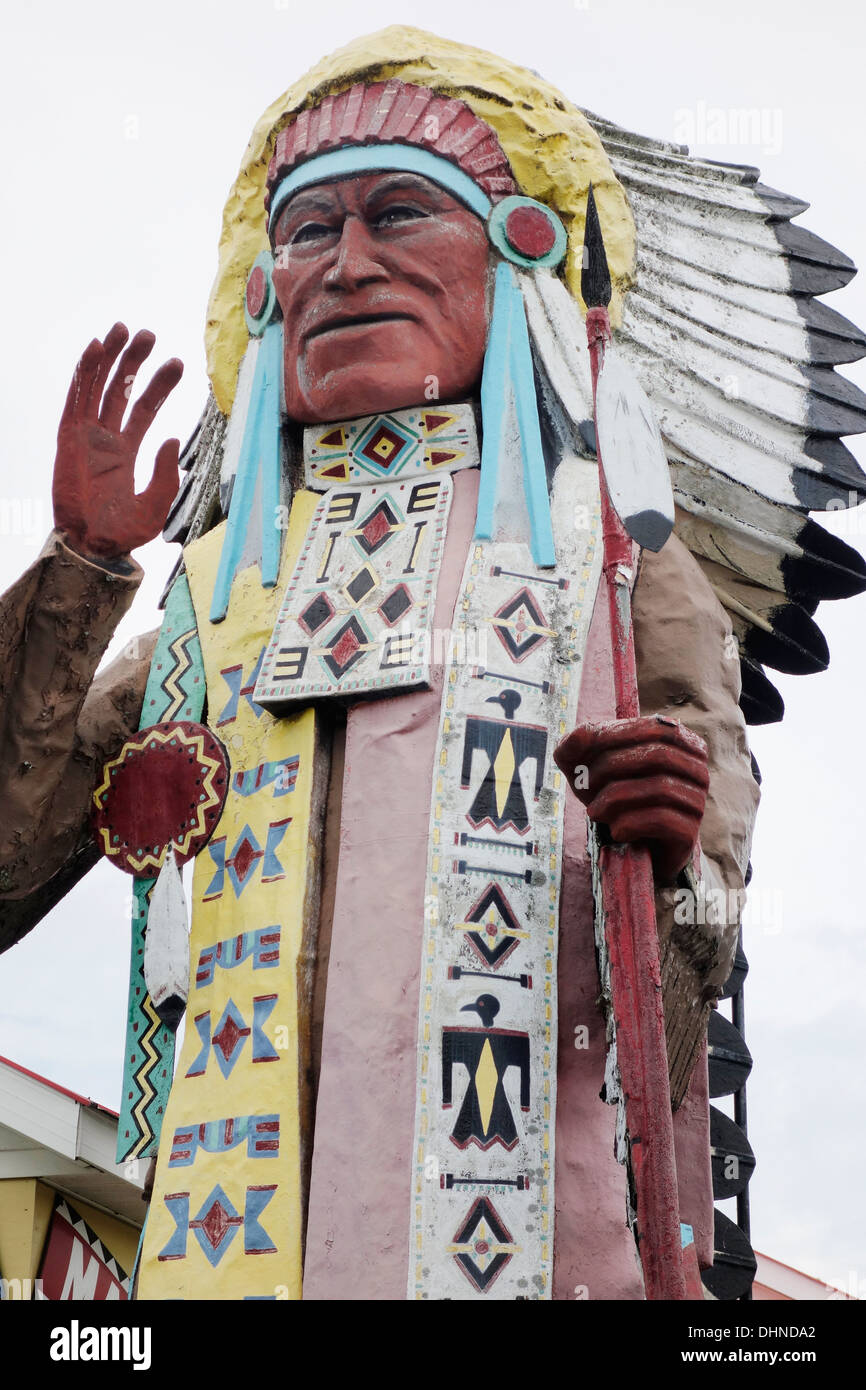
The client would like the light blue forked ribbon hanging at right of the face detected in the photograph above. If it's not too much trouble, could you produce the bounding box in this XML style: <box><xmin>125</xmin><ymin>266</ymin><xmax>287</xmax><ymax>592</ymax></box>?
<box><xmin>475</xmin><ymin>261</ymin><xmax>556</xmax><ymax>569</ymax></box>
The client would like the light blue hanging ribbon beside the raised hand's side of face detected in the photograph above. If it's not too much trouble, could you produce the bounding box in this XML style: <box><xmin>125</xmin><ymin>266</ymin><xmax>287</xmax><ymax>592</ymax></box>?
<box><xmin>210</xmin><ymin>321</ymin><xmax>282</xmax><ymax>623</ymax></box>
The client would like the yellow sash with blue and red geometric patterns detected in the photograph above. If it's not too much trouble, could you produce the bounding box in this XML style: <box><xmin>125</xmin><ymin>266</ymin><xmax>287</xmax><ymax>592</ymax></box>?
<box><xmin>139</xmin><ymin>492</ymin><xmax>324</xmax><ymax>1298</ymax></box>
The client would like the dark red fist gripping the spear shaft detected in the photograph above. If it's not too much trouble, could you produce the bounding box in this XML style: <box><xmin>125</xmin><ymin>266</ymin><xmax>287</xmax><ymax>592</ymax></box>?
<box><xmin>553</xmin><ymin>714</ymin><xmax>709</xmax><ymax>884</ymax></box>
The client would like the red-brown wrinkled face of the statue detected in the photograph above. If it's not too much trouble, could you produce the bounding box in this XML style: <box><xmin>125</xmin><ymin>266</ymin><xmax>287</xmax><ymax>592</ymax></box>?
<box><xmin>274</xmin><ymin>172</ymin><xmax>489</xmax><ymax>424</ymax></box>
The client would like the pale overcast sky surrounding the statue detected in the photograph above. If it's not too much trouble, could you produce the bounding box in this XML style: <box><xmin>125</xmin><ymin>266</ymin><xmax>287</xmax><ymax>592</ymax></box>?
<box><xmin>0</xmin><ymin>0</ymin><xmax>866</xmax><ymax>1295</ymax></box>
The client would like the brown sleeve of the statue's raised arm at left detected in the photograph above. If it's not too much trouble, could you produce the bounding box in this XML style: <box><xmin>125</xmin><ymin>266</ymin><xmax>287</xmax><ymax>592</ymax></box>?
<box><xmin>0</xmin><ymin>532</ymin><xmax>156</xmax><ymax>951</ymax></box>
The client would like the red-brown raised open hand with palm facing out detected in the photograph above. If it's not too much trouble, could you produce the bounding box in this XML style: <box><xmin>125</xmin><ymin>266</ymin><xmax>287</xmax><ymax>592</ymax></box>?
<box><xmin>53</xmin><ymin>324</ymin><xmax>183</xmax><ymax>560</ymax></box>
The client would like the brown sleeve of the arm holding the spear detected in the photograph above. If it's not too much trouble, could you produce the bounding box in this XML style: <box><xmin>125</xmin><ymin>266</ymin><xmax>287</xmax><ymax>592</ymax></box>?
<box><xmin>634</xmin><ymin>535</ymin><xmax>760</xmax><ymax>1105</ymax></box>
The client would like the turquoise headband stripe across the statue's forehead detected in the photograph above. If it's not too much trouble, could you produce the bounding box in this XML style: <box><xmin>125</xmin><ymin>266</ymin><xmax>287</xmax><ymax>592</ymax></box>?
<box><xmin>268</xmin><ymin>145</ymin><xmax>493</xmax><ymax>231</ymax></box>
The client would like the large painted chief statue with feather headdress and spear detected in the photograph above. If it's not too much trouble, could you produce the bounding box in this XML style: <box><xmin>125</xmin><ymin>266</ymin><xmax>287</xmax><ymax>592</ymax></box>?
<box><xmin>0</xmin><ymin>28</ymin><xmax>865</xmax><ymax>1301</ymax></box>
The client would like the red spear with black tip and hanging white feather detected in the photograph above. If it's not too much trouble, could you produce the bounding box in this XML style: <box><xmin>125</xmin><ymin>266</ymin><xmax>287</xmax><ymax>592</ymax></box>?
<box><xmin>581</xmin><ymin>185</ymin><xmax>688</xmax><ymax>1300</ymax></box>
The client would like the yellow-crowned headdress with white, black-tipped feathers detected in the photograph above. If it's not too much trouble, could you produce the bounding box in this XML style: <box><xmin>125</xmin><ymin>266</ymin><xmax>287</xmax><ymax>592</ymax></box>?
<box><xmin>165</xmin><ymin>26</ymin><xmax>866</xmax><ymax>723</ymax></box>
